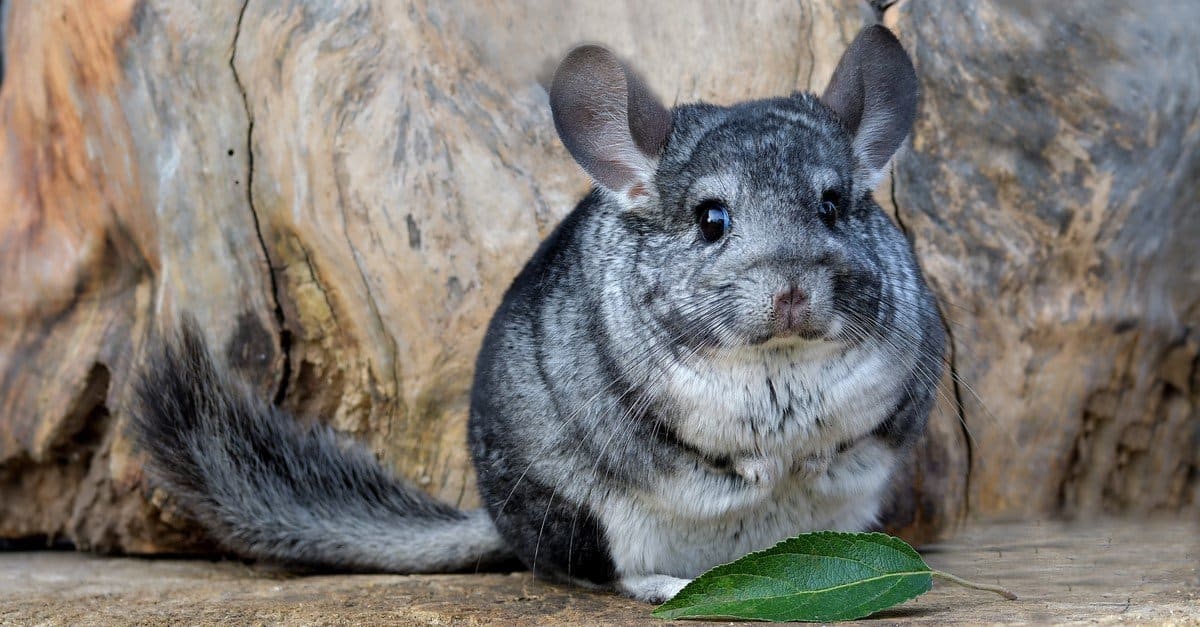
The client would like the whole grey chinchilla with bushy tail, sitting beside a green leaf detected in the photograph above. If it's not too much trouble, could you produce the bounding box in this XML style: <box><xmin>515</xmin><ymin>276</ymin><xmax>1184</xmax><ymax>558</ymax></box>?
<box><xmin>132</xmin><ymin>25</ymin><xmax>944</xmax><ymax>602</ymax></box>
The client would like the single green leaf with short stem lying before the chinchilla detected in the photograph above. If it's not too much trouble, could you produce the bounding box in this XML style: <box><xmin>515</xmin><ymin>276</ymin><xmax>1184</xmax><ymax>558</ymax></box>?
<box><xmin>654</xmin><ymin>531</ymin><xmax>935</xmax><ymax>621</ymax></box>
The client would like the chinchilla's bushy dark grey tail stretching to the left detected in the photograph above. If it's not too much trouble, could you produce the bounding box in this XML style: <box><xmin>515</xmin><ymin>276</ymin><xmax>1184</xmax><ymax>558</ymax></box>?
<box><xmin>133</xmin><ymin>318</ymin><xmax>512</xmax><ymax>573</ymax></box>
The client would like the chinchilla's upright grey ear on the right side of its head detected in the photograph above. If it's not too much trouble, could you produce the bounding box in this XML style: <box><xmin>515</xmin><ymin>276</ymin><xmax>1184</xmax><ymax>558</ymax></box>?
<box><xmin>821</xmin><ymin>25</ymin><xmax>917</xmax><ymax>190</ymax></box>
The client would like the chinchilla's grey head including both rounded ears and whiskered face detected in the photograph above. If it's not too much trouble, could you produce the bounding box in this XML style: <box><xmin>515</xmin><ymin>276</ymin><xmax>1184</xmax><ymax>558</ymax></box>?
<box><xmin>551</xmin><ymin>26</ymin><xmax>917</xmax><ymax>347</ymax></box>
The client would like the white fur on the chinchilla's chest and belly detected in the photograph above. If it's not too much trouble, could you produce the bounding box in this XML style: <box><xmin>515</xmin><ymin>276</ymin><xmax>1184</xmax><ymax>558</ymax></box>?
<box><xmin>596</xmin><ymin>338</ymin><xmax>898</xmax><ymax>578</ymax></box>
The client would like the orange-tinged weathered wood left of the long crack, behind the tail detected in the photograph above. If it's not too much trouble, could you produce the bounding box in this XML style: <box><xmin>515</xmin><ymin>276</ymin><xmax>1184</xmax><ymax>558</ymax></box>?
<box><xmin>0</xmin><ymin>1</ymin><xmax>281</xmax><ymax>551</ymax></box>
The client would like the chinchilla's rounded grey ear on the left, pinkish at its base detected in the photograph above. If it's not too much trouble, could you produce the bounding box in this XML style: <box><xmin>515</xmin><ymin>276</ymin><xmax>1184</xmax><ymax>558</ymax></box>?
<box><xmin>550</xmin><ymin>46</ymin><xmax>671</xmax><ymax>198</ymax></box>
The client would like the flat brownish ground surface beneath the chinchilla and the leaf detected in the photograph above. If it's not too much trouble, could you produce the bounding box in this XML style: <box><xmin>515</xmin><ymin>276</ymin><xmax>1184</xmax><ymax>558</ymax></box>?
<box><xmin>0</xmin><ymin>520</ymin><xmax>1200</xmax><ymax>626</ymax></box>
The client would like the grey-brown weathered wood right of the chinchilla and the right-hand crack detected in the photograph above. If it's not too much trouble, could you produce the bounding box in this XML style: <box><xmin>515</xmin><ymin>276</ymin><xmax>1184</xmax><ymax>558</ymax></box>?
<box><xmin>888</xmin><ymin>1</ymin><xmax>1200</xmax><ymax>516</ymax></box>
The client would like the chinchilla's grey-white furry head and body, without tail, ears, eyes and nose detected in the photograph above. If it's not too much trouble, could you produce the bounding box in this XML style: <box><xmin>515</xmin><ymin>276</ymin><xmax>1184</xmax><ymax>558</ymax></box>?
<box><xmin>470</xmin><ymin>26</ymin><xmax>943</xmax><ymax>599</ymax></box>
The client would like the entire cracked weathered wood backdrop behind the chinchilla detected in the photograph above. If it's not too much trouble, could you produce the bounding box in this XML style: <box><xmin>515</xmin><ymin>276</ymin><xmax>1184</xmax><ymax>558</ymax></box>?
<box><xmin>0</xmin><ymin>0</ymin><xmax>1200</xmax><ymax>553</ymax></box>
